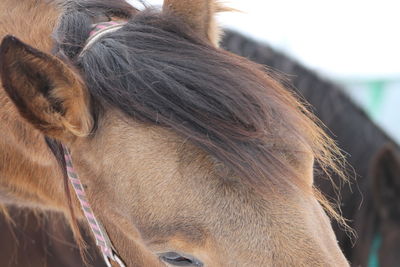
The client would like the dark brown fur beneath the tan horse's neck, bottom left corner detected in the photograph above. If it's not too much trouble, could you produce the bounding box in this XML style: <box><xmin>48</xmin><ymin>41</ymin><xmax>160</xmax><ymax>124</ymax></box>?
<box><xmin>0</xmin><ymin>207</ymin><xmax>105</xmax><ymax>267</ymax></box>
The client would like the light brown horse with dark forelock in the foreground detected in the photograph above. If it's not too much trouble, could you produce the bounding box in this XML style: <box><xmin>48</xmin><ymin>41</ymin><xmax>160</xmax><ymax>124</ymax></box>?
<box><xmin>0</xmin><ymin>0</ymin><xmax>348</xmax><ymax>266</ymax></box>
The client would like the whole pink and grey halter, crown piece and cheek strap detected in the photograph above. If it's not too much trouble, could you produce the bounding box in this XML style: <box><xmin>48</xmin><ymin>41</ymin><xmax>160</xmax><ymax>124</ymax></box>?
<box><xmin>62</xmin><ymin>21</ymin><xmax>125</xmax><ymax>267</ymax></box>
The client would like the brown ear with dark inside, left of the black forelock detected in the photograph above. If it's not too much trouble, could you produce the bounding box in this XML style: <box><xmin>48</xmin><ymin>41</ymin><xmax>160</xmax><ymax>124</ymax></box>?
<box><xmin>0</xmin><ymin>36</ymin><xmax>92</xmax><ymax>140</ymax></box>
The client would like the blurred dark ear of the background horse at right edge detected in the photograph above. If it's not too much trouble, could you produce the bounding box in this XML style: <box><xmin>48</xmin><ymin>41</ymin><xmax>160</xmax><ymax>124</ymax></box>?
<box><xmin>371</xmin><ymin>146</ymin><xmax>400</xmax><ymax>219</ymax></box>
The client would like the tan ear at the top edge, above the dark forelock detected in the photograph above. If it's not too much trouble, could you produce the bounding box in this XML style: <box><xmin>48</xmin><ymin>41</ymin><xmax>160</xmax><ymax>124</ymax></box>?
<box><xmin>163</xmin><ymin>0</ymin><xmax>230</xmax><ymax>47</ymax></box>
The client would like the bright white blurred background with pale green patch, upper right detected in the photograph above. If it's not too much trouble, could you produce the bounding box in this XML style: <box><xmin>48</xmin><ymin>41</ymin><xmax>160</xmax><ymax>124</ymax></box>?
<box><xmin>132</xmin><ymin>0</ymin><xmax>400</xmax><ymax>143</ymax></box>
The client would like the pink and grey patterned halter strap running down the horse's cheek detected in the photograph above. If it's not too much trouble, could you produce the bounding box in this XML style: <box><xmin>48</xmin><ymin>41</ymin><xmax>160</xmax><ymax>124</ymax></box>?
<box><xmin>62</xmin><ymin>145</ymin><xmax>125</xmax><ymax>267</ymax></box>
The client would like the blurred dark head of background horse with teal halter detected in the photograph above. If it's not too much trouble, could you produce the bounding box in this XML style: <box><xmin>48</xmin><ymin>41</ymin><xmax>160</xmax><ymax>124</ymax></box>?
<box><xmin>355</xmin><ymin>145</ymin><xmax>400</xmax><ymax>267</ymax></box>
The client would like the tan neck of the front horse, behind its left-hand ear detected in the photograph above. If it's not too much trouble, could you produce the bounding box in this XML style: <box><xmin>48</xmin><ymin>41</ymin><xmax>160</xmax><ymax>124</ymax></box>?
<box><xmin>0</xmin><ymin>0</ymin><xmax>65</xmax><ymax>209</ymax></box>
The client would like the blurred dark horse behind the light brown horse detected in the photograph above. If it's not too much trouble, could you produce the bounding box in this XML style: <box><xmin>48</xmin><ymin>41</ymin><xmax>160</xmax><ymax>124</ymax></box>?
<box><xmin>222</xmin><ymin>31</ymin><xmax>400</xmax><ymax>267</ymax></box>
